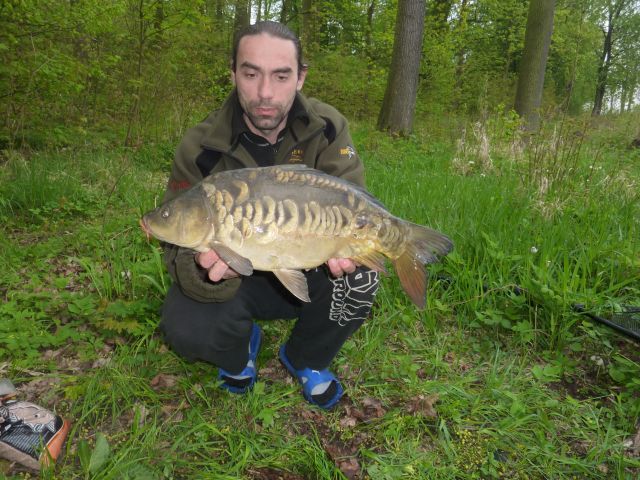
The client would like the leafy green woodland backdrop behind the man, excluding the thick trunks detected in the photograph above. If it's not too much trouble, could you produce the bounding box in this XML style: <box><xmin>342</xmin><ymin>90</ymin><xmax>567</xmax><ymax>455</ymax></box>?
<box><xmin>0</xmin><ymin>0</ymin><xmax>640</xmax><ymax>147</ymax></box>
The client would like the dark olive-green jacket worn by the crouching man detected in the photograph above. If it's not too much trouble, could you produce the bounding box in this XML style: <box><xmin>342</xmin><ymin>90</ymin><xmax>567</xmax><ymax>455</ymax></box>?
<box><xmin>164</xmin><ymin>91</ymin><xmax>364</xmax><ymax>302</ymax></box>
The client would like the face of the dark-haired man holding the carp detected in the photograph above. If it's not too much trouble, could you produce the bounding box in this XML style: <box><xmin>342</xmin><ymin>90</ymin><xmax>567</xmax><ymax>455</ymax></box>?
<box><xmin>231</xmin><ymin>33</ymin><xmax>306</xmax><ymax>141</ymax></box>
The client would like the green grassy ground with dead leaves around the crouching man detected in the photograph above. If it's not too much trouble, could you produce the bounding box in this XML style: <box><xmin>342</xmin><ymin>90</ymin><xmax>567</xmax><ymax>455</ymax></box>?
<box><xmin>0</xmin><ymin>117</ymin><xmax>640</xmax><ymax>479</ymax></box>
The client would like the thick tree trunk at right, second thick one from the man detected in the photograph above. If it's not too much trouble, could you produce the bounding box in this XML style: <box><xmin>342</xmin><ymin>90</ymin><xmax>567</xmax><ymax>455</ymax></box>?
<box><xmin>515</xmin><ymin>0</ymin><xmax>556</xmax><ymax>132</ymax></box>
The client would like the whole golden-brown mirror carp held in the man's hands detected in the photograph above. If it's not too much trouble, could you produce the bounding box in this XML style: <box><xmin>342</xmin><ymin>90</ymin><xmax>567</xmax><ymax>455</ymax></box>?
<box><xmin>141</xmin><ymin>165</ymin><xmax>453</xmax><ymax>307</ymax></box>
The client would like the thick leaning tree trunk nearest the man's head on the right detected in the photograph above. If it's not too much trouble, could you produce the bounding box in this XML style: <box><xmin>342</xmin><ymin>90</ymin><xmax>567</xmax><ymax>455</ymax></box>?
<box><xmin>378</xmin><ymin>0</ymin><xmax>426</xmax><ymax>135</ymax></box>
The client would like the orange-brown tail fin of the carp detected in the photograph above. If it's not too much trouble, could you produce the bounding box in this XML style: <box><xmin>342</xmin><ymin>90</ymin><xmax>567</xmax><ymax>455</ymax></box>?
<box><xmin>393</xmin><ymin>223</ymin><xmax>453</xmax><ymax>309</ymax></box>
